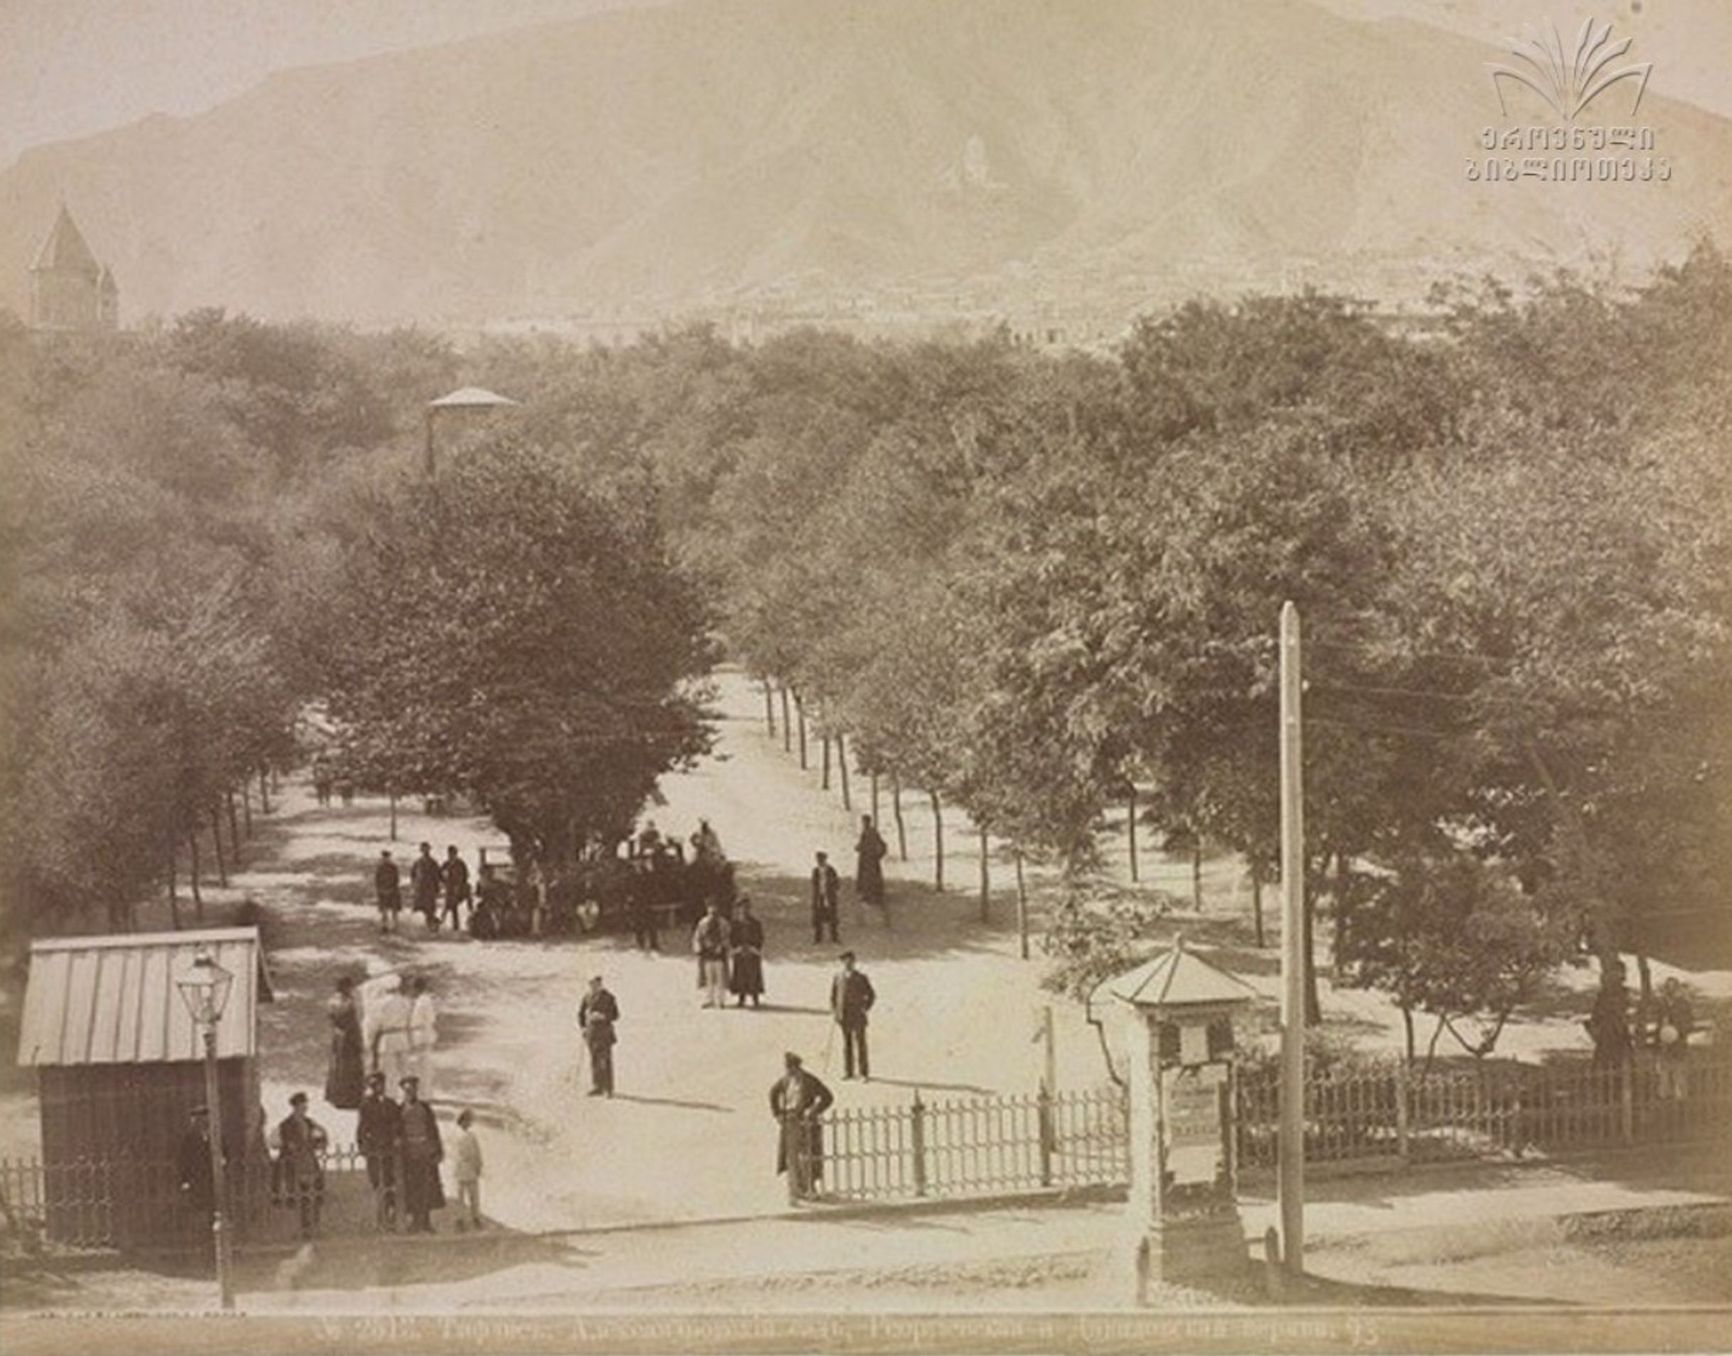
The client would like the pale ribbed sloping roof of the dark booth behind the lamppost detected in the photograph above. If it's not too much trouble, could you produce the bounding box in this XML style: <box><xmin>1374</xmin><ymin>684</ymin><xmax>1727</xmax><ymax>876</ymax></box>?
<box><xmin>17</xmin><ymin>927</ymin><xmax>270</xmax><ymax>1067</ymax></box>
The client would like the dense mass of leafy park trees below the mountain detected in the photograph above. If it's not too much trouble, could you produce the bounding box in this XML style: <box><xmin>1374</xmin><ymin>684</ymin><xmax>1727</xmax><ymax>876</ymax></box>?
<box><xmin>0</xmin><ymin>246</ymin><xmax>1732</xmax><ymax>1049</ymax></box>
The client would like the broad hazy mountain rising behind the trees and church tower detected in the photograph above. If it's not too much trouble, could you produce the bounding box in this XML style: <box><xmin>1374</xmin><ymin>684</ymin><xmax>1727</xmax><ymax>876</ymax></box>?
<box><xmin>0</xmin><ymin>0</ymin><xmax>1732</xmax><ymax>322</ymax></box>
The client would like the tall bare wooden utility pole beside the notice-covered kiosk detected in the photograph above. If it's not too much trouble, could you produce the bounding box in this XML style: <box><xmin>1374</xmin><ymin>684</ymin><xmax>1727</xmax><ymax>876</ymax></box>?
<box><xmin>1276</xmin><ymin>603</ymin><xmax>1306</xmax><ymax>1276</ymax></box>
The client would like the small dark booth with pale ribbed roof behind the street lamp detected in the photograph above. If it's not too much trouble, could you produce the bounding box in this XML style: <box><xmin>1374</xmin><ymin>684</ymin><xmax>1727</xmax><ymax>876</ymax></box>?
<box><xmin>17</xmin><ymin>927</ymin><xmax>272</xmax><ymax>1247</ymax></box>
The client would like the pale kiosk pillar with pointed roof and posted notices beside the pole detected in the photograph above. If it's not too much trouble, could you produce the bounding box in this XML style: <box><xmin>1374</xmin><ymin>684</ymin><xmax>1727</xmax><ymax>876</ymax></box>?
<box><xmin>1102</xmin><ymin>937</ymin><xmax>1257</xmax><ymax>1295</ymax></box>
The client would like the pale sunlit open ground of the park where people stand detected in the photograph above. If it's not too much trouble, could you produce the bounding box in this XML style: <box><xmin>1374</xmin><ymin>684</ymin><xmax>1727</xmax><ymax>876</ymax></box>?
<box><xmin>219</xmin><ymin>672</ymin><xmax>1105</xmax><ymax>1230</ymax></box>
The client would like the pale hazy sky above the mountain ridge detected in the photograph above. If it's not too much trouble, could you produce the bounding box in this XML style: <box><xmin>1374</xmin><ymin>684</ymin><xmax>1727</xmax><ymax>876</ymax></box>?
<box><xmin>0</xmin><ymin>0</ymin><xmax>1732</xmax><ymax>166</ymax></box>
